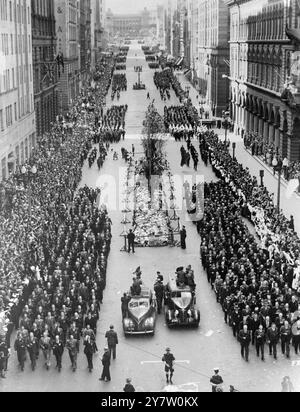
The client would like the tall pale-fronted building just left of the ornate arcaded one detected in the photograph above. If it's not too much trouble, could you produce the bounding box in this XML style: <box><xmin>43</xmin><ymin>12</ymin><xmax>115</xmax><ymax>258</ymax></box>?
<box><xmin>190</xmin><ymin>0</ymin><xmax>229</xmax><ymax>117</ymax></box>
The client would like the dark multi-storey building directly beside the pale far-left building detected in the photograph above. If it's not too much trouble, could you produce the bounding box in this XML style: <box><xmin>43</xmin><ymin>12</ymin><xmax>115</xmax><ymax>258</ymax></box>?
<box><xmin>31</xmin><ymin>0</ymin><xmax>58</xmax><ymax>137</ymax></box>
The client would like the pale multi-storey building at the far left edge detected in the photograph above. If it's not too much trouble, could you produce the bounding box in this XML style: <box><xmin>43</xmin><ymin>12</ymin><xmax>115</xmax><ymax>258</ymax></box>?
<box><xmin>0</xmin><ymin>0</ymin><xmax>36</xmax><ymax>180</ymax></box>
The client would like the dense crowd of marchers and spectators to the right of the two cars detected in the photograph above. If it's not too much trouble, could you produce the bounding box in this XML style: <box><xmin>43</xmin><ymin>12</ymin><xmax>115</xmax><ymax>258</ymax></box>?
<box><xmin>197</xmin><ymin>132</ymin><xmax>300</xmax><ymax>361</ymax></box>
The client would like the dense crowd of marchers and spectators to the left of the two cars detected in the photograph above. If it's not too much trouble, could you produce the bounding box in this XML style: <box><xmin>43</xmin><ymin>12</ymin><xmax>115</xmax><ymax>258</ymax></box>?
<box><xmin>0</xmin><ymin>57</ymin><xmax>112</xmax><ymax>377</ymax></box>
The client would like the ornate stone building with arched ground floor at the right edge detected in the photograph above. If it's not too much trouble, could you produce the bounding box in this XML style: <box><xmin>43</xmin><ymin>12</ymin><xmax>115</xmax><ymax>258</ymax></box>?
<box><xmin>226</xmin><ymin>0</ymin><xmax>300</xmax><ymax>161</ymax></box>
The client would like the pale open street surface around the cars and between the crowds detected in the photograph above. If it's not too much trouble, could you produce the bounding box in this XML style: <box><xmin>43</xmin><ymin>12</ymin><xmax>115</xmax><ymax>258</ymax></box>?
<box><xmin>0</xmin><ymin>43</ymin><xmax>300</xmax><ymax>392</ymax></box>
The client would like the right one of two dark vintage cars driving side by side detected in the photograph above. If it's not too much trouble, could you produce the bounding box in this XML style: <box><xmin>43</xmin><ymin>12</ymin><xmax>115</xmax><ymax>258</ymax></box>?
<box><xmin>165</xmin><ymin>277</ymin><xmax>200</xmax><ymax>328</ymax></box>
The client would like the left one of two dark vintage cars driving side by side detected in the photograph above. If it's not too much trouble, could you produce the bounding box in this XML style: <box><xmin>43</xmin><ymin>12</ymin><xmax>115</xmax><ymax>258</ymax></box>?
<box><xmin>123</xmin><ymin>286</ymin><xmax>157</xmax><ymax>336</ymax></box>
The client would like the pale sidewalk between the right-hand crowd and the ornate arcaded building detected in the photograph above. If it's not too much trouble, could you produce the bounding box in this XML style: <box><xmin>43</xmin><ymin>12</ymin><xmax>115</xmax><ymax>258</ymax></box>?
<box><xmin>177</xmin><ymin>74</ymin><xmax>300</xmax><ymax>236</ymax></box>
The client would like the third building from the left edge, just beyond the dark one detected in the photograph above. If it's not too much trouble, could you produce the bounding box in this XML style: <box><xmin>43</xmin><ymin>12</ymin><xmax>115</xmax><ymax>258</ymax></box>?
<box><xmin>55</xmin><ymin>0</ymin><xmax>80</xmax><ymax>113</ymax></box>
